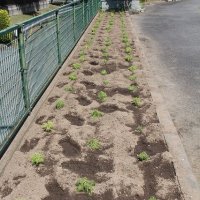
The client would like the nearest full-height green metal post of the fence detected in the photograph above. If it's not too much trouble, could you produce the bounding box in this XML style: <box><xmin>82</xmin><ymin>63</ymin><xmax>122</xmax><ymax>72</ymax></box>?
<box><xmin>17</xmin><ymin>25</ymin><xmax>30</xmax><ymax>112</ymax></box>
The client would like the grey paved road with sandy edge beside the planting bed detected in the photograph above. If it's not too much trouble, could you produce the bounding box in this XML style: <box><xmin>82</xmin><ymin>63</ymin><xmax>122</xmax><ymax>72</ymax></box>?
<box><xmin>132</xmin><ymin>0</ymin><xmax>200</xmax><ymax>183</ymax></box>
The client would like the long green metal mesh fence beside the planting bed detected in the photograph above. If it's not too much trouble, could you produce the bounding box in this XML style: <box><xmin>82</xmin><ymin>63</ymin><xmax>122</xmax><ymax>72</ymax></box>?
<box><xmin>0</xmin><ymin>0</ymin><xmax>100</xmax><ymax>155</ymax></box>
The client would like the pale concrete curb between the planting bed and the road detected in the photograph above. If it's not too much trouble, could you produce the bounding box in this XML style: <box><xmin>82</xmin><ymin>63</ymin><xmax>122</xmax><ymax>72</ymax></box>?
<box><xmin>127</xmin><ymin>13</ymin><xmax>200</xmax><ymax>200</ymax></box>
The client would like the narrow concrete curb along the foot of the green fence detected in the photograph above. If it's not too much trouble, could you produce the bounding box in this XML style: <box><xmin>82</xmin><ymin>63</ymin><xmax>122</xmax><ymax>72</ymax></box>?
<box><xmin>0</xmin><ymin>13</ymin><xmax>99</xmax><ymax>176</ymax></box>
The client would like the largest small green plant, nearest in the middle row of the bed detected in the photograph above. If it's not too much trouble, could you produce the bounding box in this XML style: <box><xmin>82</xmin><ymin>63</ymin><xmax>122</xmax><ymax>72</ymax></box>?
<box><xmin>76</xmin><ymin>177</ymin><xmax>95</xmax><ymax>195</ymax></box>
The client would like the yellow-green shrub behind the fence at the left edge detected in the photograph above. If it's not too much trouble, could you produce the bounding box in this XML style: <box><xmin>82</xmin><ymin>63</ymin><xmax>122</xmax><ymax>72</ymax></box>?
<box><xmin>0</xmin><ymin>10</ymin><xmax>12</xmax><ymax>42</ymax></box>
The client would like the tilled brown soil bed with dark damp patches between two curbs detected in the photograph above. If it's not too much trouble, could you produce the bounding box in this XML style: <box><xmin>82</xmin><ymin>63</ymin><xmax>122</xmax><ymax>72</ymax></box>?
<box><xmin>0</xmin><ymin>12</ymin><xmax>182</xmax><ymax>200</ymax></box>
